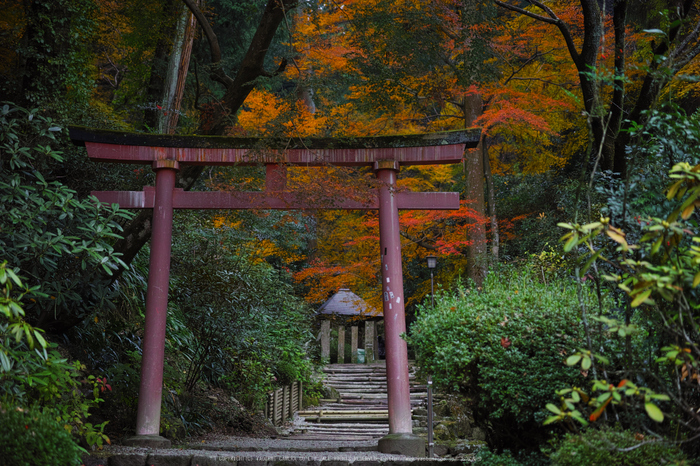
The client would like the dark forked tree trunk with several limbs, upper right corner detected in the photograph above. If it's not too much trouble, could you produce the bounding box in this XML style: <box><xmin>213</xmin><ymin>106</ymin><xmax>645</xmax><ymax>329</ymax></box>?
<box><xmin>494</xmin><ymin>0</ymin><xmax>700</xmax><ymax>176</ymax></box>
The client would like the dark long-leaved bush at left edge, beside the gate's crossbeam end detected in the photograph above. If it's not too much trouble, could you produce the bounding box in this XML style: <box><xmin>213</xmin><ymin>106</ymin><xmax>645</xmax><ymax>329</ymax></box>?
<box><xmin>0</xmin><ymin>104</ymin><xmax>131</xmax><ymax>332</ymax></box>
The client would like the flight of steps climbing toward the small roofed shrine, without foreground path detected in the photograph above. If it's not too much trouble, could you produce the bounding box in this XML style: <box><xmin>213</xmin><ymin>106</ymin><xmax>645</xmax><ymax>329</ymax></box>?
<box><xmin>290</xmin><ymin>361</ymin><xmax>427</xmax><ymax>441</ymax></box>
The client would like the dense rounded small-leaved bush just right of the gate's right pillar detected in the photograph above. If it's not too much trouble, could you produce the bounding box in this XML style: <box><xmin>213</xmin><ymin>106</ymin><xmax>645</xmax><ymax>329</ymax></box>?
<box><xmin>408</xmin><ymin>266</ymin><xmax>594</xmax><ymax>449</ymax></box>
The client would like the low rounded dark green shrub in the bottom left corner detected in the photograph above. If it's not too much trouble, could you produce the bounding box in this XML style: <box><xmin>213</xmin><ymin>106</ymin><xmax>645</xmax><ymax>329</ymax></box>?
<box><xmin>0</xmin><ymin>406</ymin><xmax>84</xmax><ymax>466</ymax></box>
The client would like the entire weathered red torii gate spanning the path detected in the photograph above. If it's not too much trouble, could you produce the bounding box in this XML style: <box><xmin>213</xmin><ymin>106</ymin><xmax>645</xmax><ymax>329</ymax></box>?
<box><xmin>69</xmin><ymin>127</ymin><xmax>480</xmax><ymax>456</ymax></box>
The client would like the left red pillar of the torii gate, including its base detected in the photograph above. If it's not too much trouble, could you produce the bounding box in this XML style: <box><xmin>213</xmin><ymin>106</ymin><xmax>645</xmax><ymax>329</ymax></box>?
<box><xmin>124</xmin><ymin>160</ymin><xmax>179</xmax><ymax>447</ymax></box>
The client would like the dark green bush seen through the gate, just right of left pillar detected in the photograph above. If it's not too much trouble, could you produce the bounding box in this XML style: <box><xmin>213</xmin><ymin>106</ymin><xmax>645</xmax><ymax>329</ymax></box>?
<box><xmin>167</xmin><ymin>214</ymin><xmax>313</xmax><ymax>407</ymax></box>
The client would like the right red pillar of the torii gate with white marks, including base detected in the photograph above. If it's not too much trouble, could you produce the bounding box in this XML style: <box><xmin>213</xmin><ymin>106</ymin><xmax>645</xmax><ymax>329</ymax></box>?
<box><xmin>374</xmin><ymin>160</ymin><xmax>425</xmax><ymax>457</ymax></box>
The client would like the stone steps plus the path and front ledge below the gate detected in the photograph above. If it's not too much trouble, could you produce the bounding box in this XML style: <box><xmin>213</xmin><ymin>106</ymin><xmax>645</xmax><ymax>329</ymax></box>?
<box><xmin>90</xmin><ymin>361</ymin><xmax>483</xmax><ymax>466</ymax></box>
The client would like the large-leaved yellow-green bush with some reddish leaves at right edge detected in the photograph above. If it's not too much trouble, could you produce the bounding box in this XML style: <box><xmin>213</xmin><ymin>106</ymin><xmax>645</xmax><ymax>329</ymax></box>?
<box><xmin>546</xmin><ymin>166</ymin><xmax>700</xmax><ymax>456</ymax></box>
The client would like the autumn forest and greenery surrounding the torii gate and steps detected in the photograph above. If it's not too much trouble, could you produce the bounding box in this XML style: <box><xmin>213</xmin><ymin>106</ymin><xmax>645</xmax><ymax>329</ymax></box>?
<box><xmin>0</xmin><ymin>0</ymin><xmax>700</xmax><ymax>464</ymax></box>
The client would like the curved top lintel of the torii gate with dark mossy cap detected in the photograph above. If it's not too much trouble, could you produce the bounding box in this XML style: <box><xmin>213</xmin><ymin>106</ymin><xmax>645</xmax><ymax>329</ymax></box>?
<box><xmin>69</xmin><ymin>126</ymin><xmax>481</xmax><ymax>166</ymax></box>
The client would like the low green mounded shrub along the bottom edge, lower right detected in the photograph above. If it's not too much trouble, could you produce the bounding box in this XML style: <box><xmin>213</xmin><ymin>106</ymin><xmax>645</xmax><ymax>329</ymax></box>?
<box><xmin>551</xmin><ymin>428</ymin><xmax>685</xmax><ymax>466</ymax></box>
